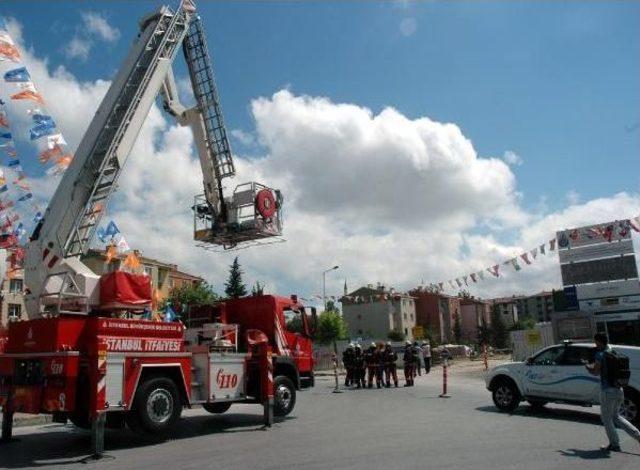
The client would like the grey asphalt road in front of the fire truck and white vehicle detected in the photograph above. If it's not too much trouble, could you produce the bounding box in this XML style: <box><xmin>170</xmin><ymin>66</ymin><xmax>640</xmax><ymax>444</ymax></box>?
<box><xmin>0</xmin><ymin>367</ymin><xmax>640</xmax><ymax>470</ymax></box>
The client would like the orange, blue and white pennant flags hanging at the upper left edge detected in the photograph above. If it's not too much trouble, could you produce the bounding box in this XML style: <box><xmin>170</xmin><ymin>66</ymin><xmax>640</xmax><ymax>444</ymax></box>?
<box><xmin>0</xmin><ymin>18</ymin><xmax>73</xmax><ymax>258</ymax></box>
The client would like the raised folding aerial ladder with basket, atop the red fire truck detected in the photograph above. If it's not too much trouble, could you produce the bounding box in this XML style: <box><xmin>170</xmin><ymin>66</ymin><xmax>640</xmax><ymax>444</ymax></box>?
<box><xmin>24</xmin><ymin>0</ymin><xmax>282</xmax><ymax>317</ymax></box>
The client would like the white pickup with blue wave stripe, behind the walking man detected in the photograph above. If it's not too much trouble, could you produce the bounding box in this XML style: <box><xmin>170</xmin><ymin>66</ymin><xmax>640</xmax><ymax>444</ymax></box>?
<box><xmin>485</xmin><ymin>342</ymin><xmax>640</xmax><ymax>424</ymax></box>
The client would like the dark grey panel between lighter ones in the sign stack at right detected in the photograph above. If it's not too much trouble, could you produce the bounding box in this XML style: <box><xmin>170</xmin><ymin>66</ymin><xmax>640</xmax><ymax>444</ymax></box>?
<box><xmin>560</xmin><ymin>255</ymin><xmax>638</xmax><ymax>284</ymax></box>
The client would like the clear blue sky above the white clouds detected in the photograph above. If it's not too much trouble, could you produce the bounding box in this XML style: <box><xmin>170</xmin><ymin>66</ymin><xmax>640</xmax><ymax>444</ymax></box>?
<box><xmin>2</xmin><ymin>1</ymin><xmax>640</xmax><ymax>209</ymax></box>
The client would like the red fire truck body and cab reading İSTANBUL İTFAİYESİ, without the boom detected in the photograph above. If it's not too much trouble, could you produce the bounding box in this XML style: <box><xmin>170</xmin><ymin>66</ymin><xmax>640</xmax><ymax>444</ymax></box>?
<box><xmin>0</xmin><ymin>292</ymin><xmax>314</xmax><ymax>446</ymax></box>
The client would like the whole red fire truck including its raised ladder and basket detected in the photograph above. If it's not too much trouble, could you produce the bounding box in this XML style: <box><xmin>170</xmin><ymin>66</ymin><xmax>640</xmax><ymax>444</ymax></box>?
<box><xmin>0</xmin><ymin>0</ymin><xmax>315</xmax><ymax>455</ymax></box>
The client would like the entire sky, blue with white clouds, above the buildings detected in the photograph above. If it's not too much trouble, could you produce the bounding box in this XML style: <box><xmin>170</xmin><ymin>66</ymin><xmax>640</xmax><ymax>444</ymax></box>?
<box><xmin>0</xmin><ymin>1</ymin><xmax>640</xmax><ymax>306</ymax></box>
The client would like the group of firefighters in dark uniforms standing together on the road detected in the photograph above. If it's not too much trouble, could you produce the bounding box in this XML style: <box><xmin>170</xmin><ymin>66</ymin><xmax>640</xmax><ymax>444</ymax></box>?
<box><xmin>342</xmin><ymin>341</ymin><xmax>431</xmax><ymax>388</ymax></box>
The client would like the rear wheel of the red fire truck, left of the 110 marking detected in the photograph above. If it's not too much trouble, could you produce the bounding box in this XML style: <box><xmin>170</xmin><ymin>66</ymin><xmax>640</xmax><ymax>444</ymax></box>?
<box><xmin>127</xmin><ymin>377</ymin><xmax>182</xmax><ymax>434</ymax></box>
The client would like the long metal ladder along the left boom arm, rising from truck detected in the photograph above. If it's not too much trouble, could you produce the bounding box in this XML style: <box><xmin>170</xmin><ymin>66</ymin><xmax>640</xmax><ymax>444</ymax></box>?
<box><xmin>61</xmin><ymin>5</ymin><xmax>189</xmax><ymax>257</ymax></box>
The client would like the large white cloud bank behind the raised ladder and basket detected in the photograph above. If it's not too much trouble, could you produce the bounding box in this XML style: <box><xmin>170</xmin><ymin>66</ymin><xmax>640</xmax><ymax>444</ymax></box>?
<box><xmin>2</xmin><ymin>16</ymin><xmax>640</xmax><ymax>304</ymax></box>
